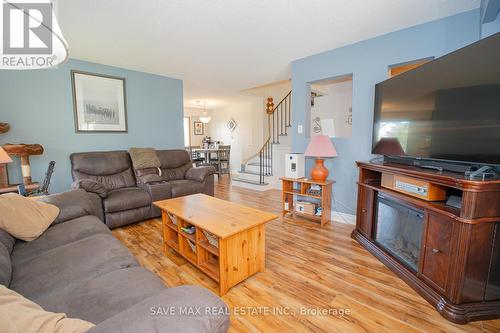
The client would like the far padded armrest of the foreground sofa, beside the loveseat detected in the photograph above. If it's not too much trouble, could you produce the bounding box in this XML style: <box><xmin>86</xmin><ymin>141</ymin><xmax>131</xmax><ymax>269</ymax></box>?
<box><xmin>38</xmin><ymin>190</ymin><xmax>102</xmax><ymax>225</ymax></box>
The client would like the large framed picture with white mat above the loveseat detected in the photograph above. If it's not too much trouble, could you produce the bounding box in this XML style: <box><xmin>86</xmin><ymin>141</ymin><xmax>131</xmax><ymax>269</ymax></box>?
<box><xmin>71</xmin><ymin>70</ymin><xmax>127</xmax><ymax>133</ymax></box>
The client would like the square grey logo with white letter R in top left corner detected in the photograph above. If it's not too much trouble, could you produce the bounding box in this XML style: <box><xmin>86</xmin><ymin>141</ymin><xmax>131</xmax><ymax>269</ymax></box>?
<box><xmin>3</xmin><ymin>3</ymin><xmax>52</xmax><ymax>54</ymax></box>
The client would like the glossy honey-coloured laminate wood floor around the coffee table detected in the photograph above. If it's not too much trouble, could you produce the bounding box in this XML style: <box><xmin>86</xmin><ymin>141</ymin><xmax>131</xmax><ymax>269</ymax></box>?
<box><xmin>113</xmin><ymin>178</ymin><xmax>500</xmax><ymax>333</ymax></box>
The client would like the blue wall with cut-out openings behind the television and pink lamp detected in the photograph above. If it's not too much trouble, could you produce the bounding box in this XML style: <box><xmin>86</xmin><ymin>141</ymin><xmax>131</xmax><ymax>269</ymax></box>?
<box><xmin>292</xmin><ymin>9</ymin><xmax>480</xmax><ymax>214</ymax></box>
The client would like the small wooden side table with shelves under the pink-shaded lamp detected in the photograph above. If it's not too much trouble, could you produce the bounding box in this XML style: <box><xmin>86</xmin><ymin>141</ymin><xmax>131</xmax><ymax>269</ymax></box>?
<box><xmin>280</xmin><ymin>177</ymin><xmax>334</xmax><ymax>227</ymax></box>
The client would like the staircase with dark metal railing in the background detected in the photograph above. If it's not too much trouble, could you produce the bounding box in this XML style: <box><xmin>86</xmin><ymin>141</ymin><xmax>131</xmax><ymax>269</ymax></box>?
<box><xmin>232</xmin><ymin>91</ymin><xmax>292</xmax><ymax>189</ymax></box>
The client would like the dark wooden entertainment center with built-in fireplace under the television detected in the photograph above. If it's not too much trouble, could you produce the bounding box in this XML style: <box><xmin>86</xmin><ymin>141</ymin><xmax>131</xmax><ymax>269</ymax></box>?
<box><xmin>352</xmin><ymin>162</ymin><xmax>500</xmax><ymax>324</ymax></box>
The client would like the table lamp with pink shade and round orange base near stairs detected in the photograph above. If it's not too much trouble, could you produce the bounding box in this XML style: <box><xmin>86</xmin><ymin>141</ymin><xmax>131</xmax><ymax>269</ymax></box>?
<box><xmin>304</xmin><ymin>135</ymin><xmax>337</xmax><ymax>182</ymax></box>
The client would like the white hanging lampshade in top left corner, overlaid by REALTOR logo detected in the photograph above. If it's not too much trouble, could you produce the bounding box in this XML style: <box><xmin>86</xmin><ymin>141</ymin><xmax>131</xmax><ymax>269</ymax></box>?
<box><xmin>0</xmin><ymin>0</ymin><xmax>68</xmax><ymax>69</ymax></box>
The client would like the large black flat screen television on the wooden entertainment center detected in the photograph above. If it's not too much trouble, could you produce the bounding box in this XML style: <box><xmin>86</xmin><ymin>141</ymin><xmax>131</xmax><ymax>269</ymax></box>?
<box><xmin>372</xmin><ymin>33</ymin><xmax>500</xmax><ymax>170</ymax></box>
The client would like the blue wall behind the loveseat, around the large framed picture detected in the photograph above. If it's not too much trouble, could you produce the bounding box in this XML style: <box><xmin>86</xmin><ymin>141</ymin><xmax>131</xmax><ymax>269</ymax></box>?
<box><xmin>0</xmin><ymin>60</ymin><xmax>184</xmax><ymax>192</ymax></box>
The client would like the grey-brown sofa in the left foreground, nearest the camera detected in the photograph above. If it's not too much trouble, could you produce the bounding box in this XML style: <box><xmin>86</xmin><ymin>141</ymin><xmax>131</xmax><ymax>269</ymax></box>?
<box><xmin>0</xmin><ymin>188</ymin><xmax>229</xmax><ymax>333</ymax></box>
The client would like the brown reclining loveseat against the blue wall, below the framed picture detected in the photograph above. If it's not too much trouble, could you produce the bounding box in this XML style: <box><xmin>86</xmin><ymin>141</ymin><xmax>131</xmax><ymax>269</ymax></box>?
<box><xmin>70</xmin><ymin>150</ymin><xmax>215</xmax><ymax>228</ymax></box>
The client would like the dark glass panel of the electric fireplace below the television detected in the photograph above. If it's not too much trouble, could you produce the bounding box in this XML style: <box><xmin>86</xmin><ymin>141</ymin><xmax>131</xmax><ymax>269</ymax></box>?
<box><xmin>375</xmin><ymin>194</ymin><xmax>424</xmax><ymax>271</ymax></box>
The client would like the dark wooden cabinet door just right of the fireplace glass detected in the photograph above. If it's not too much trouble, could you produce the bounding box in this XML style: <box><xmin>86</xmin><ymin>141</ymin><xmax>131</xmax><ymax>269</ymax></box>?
<box><xmin>421</xmin><ymin>214</ymin><xmax>453</xmax><ymax>292</ymax></box>
